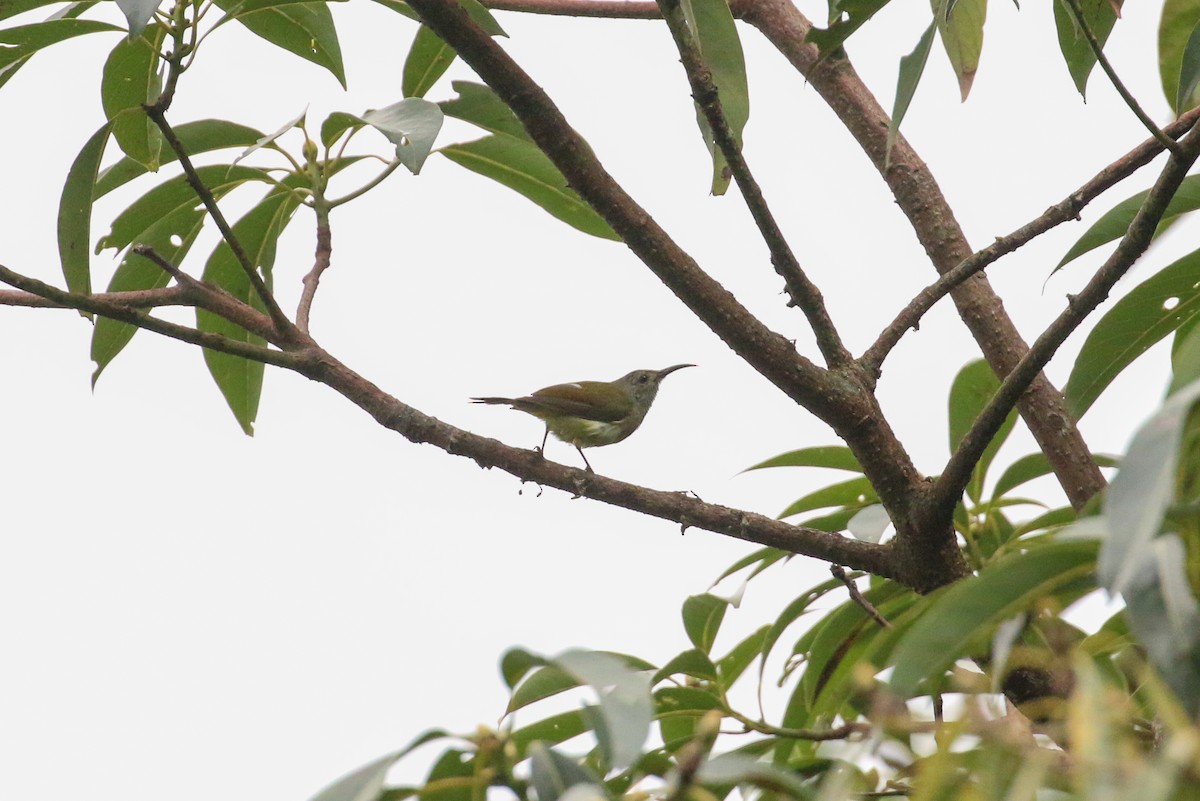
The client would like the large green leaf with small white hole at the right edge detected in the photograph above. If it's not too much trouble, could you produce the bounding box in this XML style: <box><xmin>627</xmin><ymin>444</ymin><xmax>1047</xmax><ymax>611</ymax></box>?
<box><xmin>1063</xmin><ymin>251</ymin><xmax>1200</xmax><ymax>420</ymax></box>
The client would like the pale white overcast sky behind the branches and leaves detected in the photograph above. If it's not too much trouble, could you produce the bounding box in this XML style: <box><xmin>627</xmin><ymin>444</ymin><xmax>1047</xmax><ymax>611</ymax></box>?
<box><xmin>0</xmin><ymin>0</ymin><xmax>1188</xmax><ymax>801</ymax></box>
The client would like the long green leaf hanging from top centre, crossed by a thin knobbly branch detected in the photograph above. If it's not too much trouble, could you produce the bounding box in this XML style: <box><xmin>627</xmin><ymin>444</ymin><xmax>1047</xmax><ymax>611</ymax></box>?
<box><xmin>680</xmin><ymin>0</ymin><xmax>750</xmax><ymax>194</ymax></box>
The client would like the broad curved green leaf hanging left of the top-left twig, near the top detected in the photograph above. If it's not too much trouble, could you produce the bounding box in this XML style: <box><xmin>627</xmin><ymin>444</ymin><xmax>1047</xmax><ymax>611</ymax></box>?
<box><xmin>100</xmin><ymin>23</ymin><xmax>166</xmax><ymax>173</ymax></box>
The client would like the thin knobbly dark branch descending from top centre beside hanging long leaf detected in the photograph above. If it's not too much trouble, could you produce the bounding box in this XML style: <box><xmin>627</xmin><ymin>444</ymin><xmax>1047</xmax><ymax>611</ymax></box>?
<box><xmin>659</xmin><ymin>0</ymin><xmax>852</xmax><ymax>367</ymax></box>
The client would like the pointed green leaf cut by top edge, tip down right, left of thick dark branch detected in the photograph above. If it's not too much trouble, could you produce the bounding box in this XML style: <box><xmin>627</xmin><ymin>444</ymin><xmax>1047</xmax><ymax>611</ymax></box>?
<box><xmin>215</xmin><ymin>0</ymin><xmax>346</xmax><ymax>89</ymax></box>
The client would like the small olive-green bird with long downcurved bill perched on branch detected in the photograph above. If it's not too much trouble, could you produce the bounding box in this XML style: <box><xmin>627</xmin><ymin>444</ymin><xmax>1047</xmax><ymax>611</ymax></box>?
<box><xmin>470</xmin><ymin>365</ymin><xmax>695</xmax><ymax>472</ymax></box>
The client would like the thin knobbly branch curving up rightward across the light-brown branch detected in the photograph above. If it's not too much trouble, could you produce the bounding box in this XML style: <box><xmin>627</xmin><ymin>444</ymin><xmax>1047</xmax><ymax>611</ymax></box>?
<box><xmin>859</xmin><ymin>107</ymin><xmax>1200</xmax><ymax>378</ymax></box>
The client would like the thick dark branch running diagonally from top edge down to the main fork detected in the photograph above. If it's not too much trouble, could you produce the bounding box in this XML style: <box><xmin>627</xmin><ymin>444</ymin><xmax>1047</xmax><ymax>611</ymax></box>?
<box><xmin>409</xmin><ymin>0</ymin><xmax>924</xmax><ymax>529</ymax></box>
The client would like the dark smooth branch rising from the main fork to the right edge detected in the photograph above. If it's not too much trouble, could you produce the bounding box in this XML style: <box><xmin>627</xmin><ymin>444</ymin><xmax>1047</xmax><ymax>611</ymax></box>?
<box><xmin>932</xmin><ymin>131</ymin><xmax>1200</xmax><ymax>514</ymax></box>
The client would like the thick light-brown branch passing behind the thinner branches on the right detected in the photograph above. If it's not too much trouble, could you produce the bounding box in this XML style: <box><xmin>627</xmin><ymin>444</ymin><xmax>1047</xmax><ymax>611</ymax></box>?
<box><xmin>742</xmin><ymin>0</ymin><xmax>1104</xmax><ymax>508</ymax></box>
